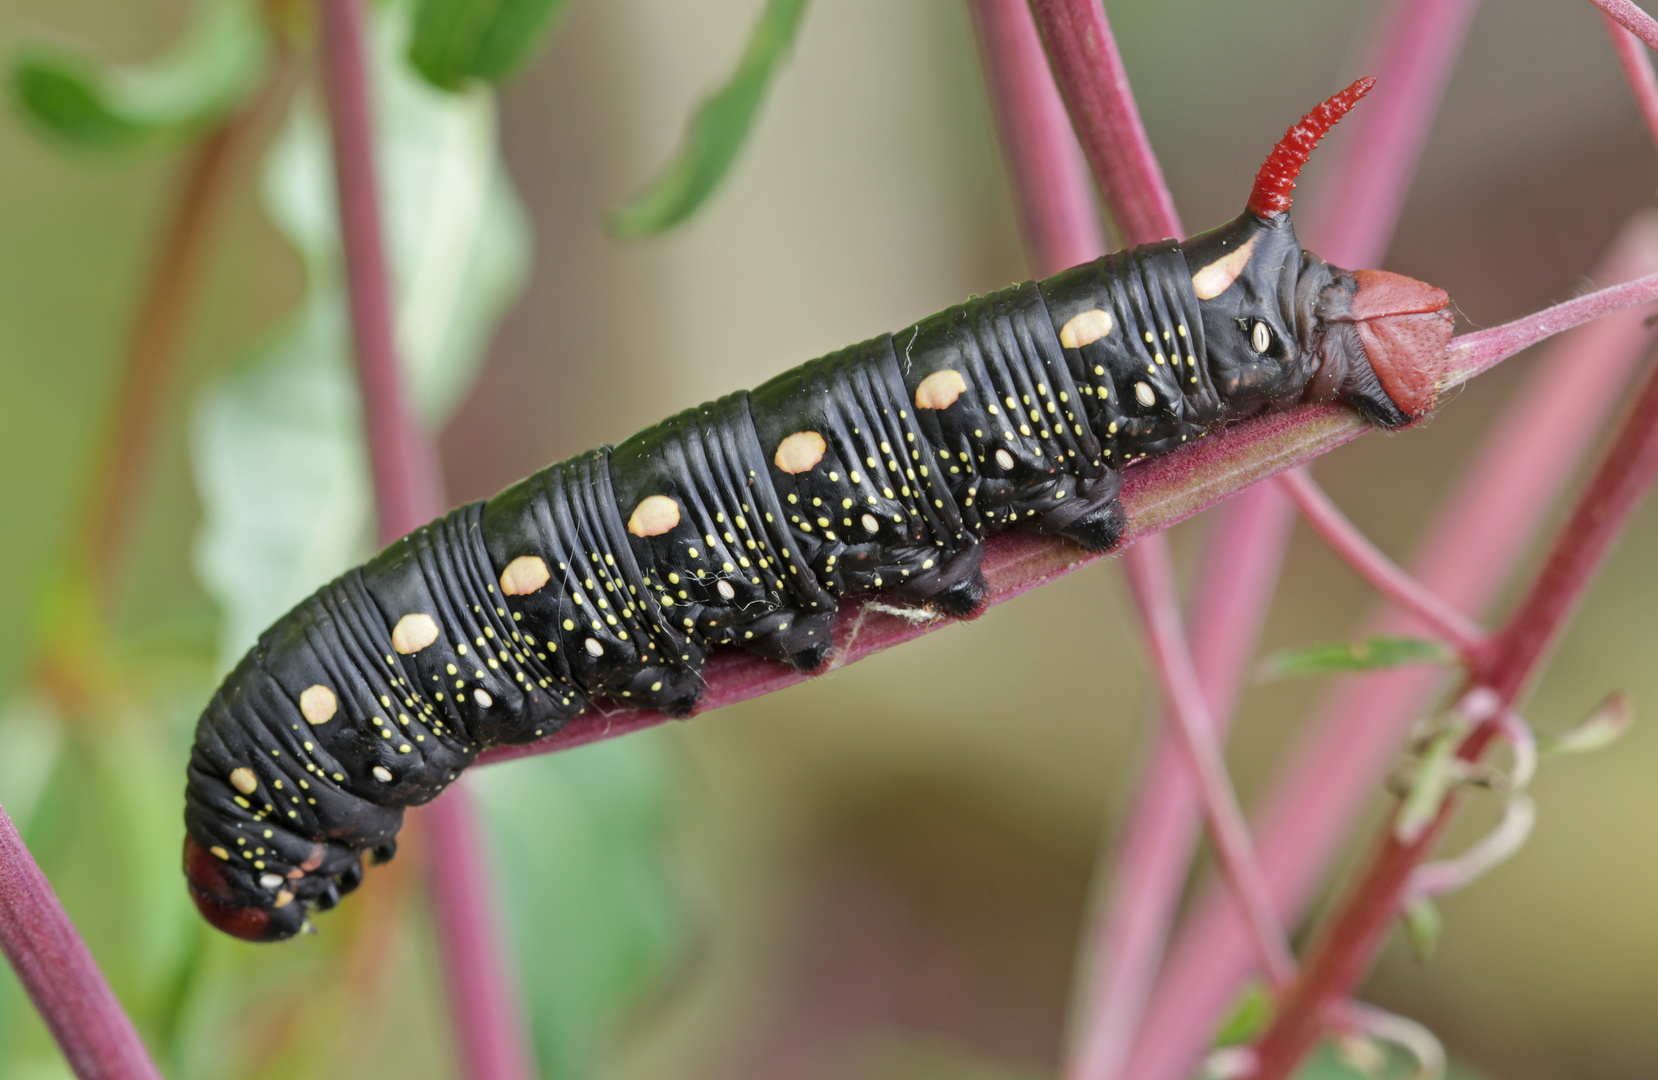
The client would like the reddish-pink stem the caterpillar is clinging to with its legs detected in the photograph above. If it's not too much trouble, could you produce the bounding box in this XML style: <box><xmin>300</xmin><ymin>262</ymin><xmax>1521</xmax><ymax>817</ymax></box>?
<box><xmin>479</xmin><ymin>262</ymin><xmax>1658</xmax><ymax>769</ymax></box>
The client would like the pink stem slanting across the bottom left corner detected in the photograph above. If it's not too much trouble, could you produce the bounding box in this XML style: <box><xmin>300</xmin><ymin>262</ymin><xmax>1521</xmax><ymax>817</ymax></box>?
<box><xmin>0</xmin><ymin>808</ymin><xmax>161</xmax><ymax>1080</ymax></box>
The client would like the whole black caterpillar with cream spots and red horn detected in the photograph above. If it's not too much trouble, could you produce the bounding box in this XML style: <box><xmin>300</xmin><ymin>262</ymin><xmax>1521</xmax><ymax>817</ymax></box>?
<box><xmin>184</xmin><ymin>80</ymin><xmax>1451</xmax><ymax>941</ymax></box>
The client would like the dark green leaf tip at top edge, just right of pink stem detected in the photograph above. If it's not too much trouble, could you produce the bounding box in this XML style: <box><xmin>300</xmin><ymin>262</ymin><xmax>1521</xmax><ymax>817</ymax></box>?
<box><xmin>410</xmin><ymin>0</ymin><xmax>567</xmax><ymax>90</ymax></box>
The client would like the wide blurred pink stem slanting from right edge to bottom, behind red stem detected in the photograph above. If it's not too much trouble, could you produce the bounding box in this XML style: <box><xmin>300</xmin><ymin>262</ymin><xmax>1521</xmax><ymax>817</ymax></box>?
<box><xmin>1124</xmin><ymin>214</ymin><xmax>1658</xmax><ymax>1080</ymax></box>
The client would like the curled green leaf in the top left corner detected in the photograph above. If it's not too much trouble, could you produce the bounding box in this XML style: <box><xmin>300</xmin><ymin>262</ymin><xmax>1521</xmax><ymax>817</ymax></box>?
<box><xmin>12</xmin><ymin>0</ymin><xmax>269</xmax><ymax>149</ymax></box>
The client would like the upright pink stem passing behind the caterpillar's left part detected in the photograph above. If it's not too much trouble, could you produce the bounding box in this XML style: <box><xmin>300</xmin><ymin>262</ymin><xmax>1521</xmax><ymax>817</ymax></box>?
<box><xmin>322</xmin><ymin>0</ymin><xmax>534</xmax><ymax>1080</ymax></box>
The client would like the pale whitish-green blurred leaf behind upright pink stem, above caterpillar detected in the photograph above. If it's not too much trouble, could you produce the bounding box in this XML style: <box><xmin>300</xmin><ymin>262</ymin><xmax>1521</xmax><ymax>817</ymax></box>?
<box><xmin>191</xmin><ymin>7</ymin><xmax>529</xmax><ymax>664</ymax></box>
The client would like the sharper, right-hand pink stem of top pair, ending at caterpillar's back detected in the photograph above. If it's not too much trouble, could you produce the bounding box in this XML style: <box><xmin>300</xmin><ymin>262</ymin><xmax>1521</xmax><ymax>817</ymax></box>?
<box><xmin>1031</xmin><ymin>0</ymin><xmax>1184</xmax><ymax>246</ymax></box>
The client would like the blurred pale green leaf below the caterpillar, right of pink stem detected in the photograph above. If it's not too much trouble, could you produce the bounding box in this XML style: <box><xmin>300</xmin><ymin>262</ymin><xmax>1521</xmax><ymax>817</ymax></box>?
<box><xmin>473</xmin><ymin>737</ymin><xmax>685</xmax><ymax>1077</ymax></box>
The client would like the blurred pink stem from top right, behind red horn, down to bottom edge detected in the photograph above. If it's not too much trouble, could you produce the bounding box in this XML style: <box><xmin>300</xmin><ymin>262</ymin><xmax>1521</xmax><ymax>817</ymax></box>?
<box><xmin>1066</xmin><ymin>0</ymin><xmax>1476</xmax><ymax>1080</ymax></box>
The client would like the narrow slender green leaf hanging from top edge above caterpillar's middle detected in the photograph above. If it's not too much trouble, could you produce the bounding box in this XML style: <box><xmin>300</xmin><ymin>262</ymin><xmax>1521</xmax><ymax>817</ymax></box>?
<box><xmin>610</xmin><ymin>0</ymin><xmax>806</xmax><ymax>237</ymax></box>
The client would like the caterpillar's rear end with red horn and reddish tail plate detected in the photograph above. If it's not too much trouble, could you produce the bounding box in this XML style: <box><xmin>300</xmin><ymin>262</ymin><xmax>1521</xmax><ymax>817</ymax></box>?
<box><xmin>1182</xmin><ymin>78</ymin><xmax>1452</xmax><ymax>428</ymax></box>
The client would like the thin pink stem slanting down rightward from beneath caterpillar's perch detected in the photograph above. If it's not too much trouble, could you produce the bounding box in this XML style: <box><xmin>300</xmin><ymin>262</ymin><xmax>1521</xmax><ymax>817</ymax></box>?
<box><xmin>1124</xmin><ymin>536</ymin><xmax>1295</xmax><ymax>987</ymax></box>
